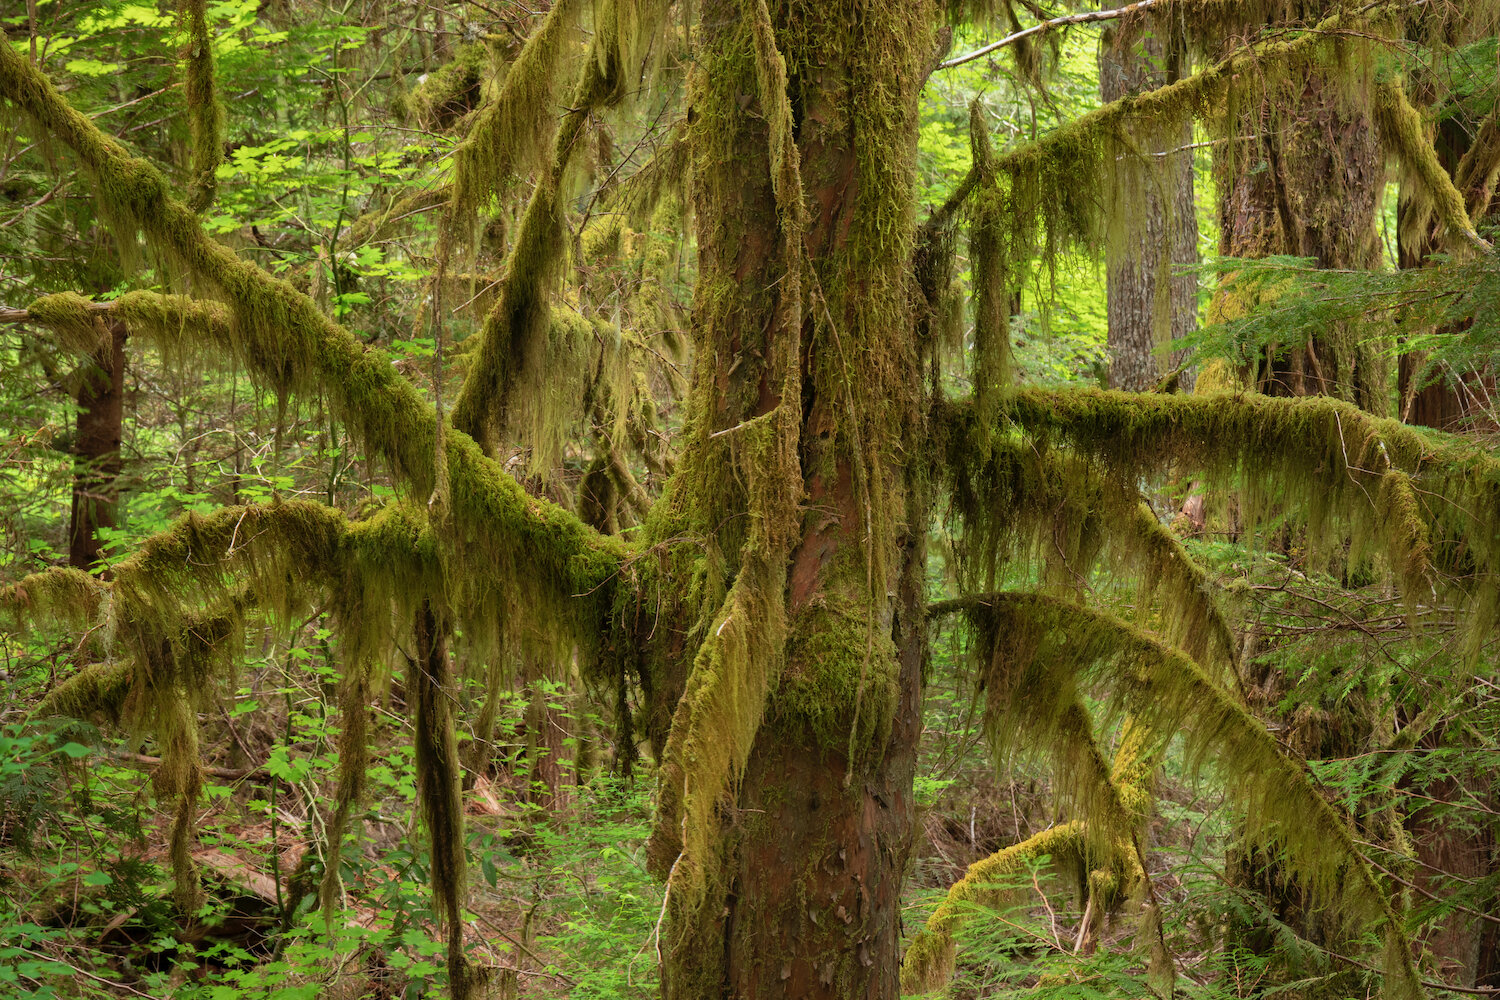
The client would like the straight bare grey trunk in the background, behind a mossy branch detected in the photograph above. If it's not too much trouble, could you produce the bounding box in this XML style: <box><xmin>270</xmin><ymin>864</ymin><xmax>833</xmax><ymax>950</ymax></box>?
<box><xmin>1100</xmin><ymin>21</ymin><xmax>1199</xmax><ymax>391</ymax></box>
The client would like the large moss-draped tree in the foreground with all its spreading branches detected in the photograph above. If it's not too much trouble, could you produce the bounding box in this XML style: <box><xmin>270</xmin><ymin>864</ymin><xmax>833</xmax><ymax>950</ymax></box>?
<box><xmin>0</xmin><ymin>0</ymin><xmax>1500</xmax><ymax>999</ymax></box>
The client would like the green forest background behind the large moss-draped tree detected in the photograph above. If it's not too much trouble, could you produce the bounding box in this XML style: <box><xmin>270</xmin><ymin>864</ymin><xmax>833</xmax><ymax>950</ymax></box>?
<box><xmin>0</xmin><ymin>0</ymin><xmax>1500</xmax><ymax>1000</ymax></box>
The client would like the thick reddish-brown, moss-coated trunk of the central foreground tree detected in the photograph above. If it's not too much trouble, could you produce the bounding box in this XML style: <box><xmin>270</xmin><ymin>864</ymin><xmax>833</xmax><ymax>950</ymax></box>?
<box><xmin>645</xmin><ymin>0</ymin><xmax>938</xmax><ymax>1000</ymax></box>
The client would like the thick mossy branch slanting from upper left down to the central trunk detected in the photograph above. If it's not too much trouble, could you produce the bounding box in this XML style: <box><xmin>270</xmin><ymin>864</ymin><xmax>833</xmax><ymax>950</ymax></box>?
<box><xmin>0</xmin><ymin>46</ymin><xmax>624</xmax><ymax>617</ymax></box>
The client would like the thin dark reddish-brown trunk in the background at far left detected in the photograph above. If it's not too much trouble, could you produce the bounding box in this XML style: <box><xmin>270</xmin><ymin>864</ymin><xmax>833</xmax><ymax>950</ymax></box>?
<box><xmin>68</xmin><ymin>319</ymin><xmax>125</xmax><ymax>570</ymax></box>
